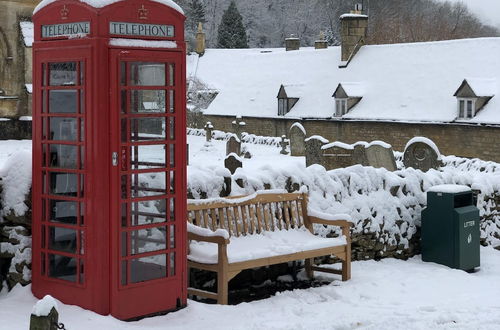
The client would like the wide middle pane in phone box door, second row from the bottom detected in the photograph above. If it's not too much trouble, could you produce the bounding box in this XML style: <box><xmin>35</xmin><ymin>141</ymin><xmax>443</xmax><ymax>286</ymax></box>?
<box><xmin>130</xmin><ymin>227</ymin><xmax>167</xmax><ymax>255</ymax></box>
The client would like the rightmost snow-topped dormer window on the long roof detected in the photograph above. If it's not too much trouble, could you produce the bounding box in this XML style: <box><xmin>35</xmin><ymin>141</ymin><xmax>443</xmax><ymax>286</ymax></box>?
<box><xmin>454</xmin><ymin>78</ymin><xmax>496</xmax><ymax>119</ymax></box>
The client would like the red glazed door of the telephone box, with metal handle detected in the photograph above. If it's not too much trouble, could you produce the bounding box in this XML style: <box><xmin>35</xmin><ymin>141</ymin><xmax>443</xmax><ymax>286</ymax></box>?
<box><xmin>110</xmin><ymin>49</ymin><xmax>186</xmax><ymax>318</ymax></box>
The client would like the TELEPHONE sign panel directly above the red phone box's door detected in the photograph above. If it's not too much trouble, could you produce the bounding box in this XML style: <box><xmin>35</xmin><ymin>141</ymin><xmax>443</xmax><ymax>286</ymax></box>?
<box><xmin>109</xmin><ymin>22</ymin><xmax>175</xmax><ymax>37</ymax></box>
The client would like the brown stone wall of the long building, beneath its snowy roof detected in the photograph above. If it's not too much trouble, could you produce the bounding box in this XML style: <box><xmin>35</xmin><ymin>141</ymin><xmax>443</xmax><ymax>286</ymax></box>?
<box><xmin>200</xmin><ymin>116</ymin><xmax>500</xmax><ymax>162</ymax></box>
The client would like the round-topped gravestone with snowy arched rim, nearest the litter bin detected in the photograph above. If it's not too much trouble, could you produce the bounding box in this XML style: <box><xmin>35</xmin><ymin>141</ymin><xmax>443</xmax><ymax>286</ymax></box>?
<box><xmin>403</xmin><ymin>137</ymin><xmax>441</xmax><ymax>172</ymax></box>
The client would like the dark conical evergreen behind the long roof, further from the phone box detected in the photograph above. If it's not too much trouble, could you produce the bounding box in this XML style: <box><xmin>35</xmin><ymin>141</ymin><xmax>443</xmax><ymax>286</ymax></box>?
<box><xmin>217</xmin><ymin>1</ymin><xmax>248</xmax><ymax>48</ymax></box>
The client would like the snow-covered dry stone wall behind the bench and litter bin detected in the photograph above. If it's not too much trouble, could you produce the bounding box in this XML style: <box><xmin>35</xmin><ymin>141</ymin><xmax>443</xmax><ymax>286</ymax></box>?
<box><xmin>188</xmin><ymin>157</ymin><xmax>500</xmax><ymax>259</ymax></box>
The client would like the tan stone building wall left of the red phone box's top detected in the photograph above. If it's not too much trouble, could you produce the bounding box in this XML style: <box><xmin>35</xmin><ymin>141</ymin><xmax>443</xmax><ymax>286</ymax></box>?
<box><xmin>0</xmin><ymin>0</ymin><xmax>40</xmax><ymax>117</ymax></box>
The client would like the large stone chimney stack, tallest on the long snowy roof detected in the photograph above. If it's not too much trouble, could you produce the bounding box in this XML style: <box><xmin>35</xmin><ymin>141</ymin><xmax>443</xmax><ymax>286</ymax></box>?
<box><xmin>340</xmin><ymin>4</ymin><xmax>368</xmax><ymax>68</ymax></box>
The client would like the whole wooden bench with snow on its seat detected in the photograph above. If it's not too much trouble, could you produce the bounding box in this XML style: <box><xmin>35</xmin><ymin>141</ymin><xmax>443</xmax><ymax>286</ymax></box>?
<box><xmin>188</xmin><ymin>192</ymin><xmax>351</xmax><ymax>304</ymax></box>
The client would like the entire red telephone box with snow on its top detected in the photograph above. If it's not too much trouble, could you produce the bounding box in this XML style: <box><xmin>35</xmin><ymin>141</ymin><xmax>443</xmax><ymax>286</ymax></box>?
<box><xmin>32</xmin><ymin>0</ymin><xmax>187</xmax><ymax>319</ymax></box>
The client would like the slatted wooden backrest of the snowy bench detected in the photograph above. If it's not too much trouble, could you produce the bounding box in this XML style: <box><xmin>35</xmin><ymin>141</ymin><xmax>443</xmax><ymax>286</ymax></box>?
<box><xmin>188</xmin><ymin>193</ymin><xmax>311</xmax><ymax>237</ymax></box>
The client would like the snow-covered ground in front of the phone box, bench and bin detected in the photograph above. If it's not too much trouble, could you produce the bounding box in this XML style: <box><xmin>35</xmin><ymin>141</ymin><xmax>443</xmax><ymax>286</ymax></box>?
<box><xmin>0</xmin><ymin>248</ymin><xmax>500</xmax><ymax>330</ymax></box>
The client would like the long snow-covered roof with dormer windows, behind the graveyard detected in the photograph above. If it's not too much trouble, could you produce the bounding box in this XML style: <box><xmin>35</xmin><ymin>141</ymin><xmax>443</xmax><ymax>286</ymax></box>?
<box><xmin>188</xmin><ymin>38</ymin><xmax>500</xmax><ymax>124</ymax></box>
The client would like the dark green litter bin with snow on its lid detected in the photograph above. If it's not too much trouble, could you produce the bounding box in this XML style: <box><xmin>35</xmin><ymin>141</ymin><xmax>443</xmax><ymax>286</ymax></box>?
<box><xmin>422</xmin><ymin>185</ymin><xmax>480</xmax><ymax>271</ymax></box>
